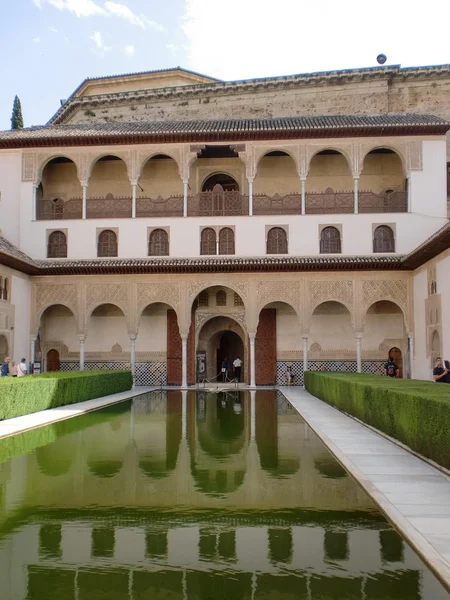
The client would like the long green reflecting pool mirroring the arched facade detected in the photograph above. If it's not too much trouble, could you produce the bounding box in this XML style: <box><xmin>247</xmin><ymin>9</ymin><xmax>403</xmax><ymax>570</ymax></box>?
<box><xmin>0</xmin><ymin>391</ymin><xmax>450</xmax><ymax>600</ymax></box>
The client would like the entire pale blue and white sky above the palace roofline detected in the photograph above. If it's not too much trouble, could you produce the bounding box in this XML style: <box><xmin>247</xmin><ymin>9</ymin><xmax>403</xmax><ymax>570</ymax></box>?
<box><xmin>0</xmin><ymin>0</ymin><xmax>450</xmax><ymax>130</ymax></box>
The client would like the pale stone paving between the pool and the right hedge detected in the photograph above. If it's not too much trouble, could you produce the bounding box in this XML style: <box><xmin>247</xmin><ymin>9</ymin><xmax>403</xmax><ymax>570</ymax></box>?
<box><xmin>282</xmin><ymin>387</ymin><xmax>450</xmax><ymax>589</ymax></box>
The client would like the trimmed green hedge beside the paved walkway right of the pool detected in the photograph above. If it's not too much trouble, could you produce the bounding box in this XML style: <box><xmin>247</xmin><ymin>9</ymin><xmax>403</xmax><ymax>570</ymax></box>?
<box><xmin>305</xmin><ymin>371</ymin><xmax>450</xmax><ymax>468</ymax></box>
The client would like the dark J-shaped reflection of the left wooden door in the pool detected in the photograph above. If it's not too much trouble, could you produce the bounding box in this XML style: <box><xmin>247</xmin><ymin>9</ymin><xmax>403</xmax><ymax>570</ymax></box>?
<box><xmin>139</xmin><ymin>391</ymin><xmax>182</xmax><ymax>479</ymax></box>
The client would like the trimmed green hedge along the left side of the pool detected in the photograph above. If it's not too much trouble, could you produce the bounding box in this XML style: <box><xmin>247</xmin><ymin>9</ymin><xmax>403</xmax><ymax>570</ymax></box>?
<box><xmin>0</xmin><ymin>370</ymin><xmax>133</xmax><ymax>420</ymax></box>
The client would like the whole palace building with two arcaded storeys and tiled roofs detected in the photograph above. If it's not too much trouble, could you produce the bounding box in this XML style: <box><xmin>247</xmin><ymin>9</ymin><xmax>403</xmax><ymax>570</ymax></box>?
<box><xmin>0</xmin><ymin>65</ymin><xmax>450</xmax><ymax>385</ymax></box>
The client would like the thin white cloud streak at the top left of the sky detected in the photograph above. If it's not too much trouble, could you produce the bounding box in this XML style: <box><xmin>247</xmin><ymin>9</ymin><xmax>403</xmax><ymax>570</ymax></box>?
<box><xmin>33</xmin><ymin>0</ymin><xmax>164</xmax><ymax>31</ymax></box>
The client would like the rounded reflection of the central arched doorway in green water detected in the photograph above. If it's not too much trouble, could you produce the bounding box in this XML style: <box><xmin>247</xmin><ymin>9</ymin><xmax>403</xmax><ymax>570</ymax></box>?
<box><xmin>197</xmin><ymin>392</ymin><xmax>246</xmax><ymax>457</ymax></box>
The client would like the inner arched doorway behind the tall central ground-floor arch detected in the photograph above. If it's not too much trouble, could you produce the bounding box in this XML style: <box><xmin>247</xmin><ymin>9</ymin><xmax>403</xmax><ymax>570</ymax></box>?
<box><xmin>196</xmin><ymin>315</ymin><xmax>248</xmax><ymax>381</ymax></box>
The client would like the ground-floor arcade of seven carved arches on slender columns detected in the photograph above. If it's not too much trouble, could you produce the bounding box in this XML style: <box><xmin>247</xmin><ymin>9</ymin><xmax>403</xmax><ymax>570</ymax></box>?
<box><xmin>32</xmin><ymin>273</ymin><xmax>412</xmax><ymax>385</ymax></box>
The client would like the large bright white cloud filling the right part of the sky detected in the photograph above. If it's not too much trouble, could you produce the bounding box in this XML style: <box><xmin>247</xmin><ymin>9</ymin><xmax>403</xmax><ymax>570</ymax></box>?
<box><xmin>183</xmin><ymin>0</ymin><xmax>450</xmax><ymax>79</ymax></box>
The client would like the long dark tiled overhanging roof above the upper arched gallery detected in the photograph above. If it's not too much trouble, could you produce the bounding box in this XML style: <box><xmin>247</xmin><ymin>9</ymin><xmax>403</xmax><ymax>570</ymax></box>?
<box><xmin>0</xmin><ymin>113</ymin><xmax>450</xmax><ymax>148</ymax></box>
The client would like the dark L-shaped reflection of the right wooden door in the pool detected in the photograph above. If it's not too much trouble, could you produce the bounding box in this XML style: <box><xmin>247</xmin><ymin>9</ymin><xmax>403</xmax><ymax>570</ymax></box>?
<box><xmin>256</xmin><ymin>390</ymin><xmax>300</xmax><ymax>477</ymax></box>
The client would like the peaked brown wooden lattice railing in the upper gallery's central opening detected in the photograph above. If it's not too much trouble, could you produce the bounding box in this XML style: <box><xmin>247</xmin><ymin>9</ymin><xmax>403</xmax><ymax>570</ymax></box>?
<box><xmin>188</xmin><ymin>185</ymin><xmax>248</xmax><ymax>217</ymax></box>
